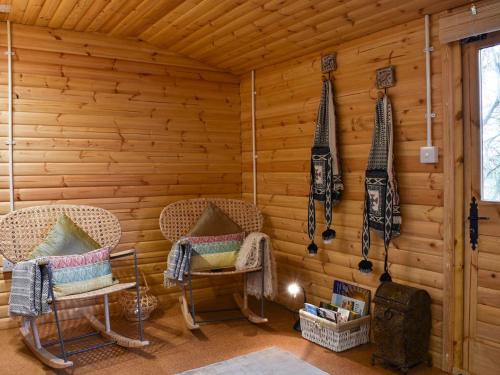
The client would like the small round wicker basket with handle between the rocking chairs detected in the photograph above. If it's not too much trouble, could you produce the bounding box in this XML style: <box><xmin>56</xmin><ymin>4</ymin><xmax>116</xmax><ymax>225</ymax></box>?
<box><xmin>119</xmin><ymin>272</ymin><xmax>158</xmax><ymax>322</ymax></box>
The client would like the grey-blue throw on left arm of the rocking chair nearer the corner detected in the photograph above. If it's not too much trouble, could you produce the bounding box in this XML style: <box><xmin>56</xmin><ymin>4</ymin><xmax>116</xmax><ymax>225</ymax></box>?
<box><xmin>163</xmin><ymin>238</ymin><xmax>192</xmax><ymax>288</ymax></box>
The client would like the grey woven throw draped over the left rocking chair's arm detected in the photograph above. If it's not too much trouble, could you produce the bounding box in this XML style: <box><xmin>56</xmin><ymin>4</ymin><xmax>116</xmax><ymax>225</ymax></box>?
<box><xmin>9</xmin><ymin>258</ymin><xmax>50</xmax><ymax>318</ymax></box>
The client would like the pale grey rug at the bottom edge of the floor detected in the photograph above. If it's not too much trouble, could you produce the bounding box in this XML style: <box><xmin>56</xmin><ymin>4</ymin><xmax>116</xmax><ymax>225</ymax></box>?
<box><xmin>178</xmin><ymin>347</ymin><xmax>328</xmax><ymax>375</ymax></box>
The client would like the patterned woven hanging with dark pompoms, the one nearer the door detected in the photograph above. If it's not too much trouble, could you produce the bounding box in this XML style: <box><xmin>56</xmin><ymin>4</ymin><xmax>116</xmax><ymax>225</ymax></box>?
<box><xmin>359</xmin><ymin>95</ymin><xmax>401</xmax><ymax>281</ymax></box>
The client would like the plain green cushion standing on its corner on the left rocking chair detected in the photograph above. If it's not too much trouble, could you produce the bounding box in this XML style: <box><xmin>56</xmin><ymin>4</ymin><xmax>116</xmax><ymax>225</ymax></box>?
<box><xmin>30</xmin><ymin>214</ymin><xmax>101</xmax><ymax>259</ymax></box>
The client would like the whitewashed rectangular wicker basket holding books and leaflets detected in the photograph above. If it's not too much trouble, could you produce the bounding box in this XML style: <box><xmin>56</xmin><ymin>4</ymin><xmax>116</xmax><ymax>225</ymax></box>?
<box><xmin>300</xmin><ymin>310</ymin><xmax>371</xmax><ymax>352</ymax></box>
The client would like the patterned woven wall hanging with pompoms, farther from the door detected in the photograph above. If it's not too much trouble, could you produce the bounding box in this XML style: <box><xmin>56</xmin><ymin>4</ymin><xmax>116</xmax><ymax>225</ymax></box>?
<box><xmin>307</xmin><ymin>79</ymin><xmax>344</xmax><ymax>254</ymax></box>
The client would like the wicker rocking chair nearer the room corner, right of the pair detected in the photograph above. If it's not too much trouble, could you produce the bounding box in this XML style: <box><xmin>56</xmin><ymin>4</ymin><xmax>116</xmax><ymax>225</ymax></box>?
<box><xmin>160</xmin><ymin>198</ymin><xmax>267</xmax><ymax>330</ymax></box>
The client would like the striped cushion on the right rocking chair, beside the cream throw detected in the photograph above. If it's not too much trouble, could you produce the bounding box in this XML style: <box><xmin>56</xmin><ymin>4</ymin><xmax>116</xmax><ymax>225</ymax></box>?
<box><xmin>187</xmin><ymin>233</ymin><xmax>245</xmax><ymax>271</ymax></box>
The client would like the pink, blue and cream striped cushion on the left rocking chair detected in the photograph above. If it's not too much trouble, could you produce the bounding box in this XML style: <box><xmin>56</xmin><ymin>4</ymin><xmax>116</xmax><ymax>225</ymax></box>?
<box><xmin>48</xmin><ymin>247</ymin><xmax>115</xmax><ymax>298</ymax></box>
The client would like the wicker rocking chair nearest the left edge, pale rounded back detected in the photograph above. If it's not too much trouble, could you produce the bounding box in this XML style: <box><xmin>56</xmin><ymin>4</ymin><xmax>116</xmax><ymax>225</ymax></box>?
<box><xmin>0</xmin><ymin>205</ymin><xmax>149</xmax><ymax>368</ymax></box>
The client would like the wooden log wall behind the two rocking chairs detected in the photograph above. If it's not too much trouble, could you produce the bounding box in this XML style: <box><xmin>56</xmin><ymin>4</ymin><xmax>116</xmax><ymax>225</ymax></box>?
<box><xmin>0</xmin><ymin>24</ymin><xmax>241</xmax><ymax>328</ymax></box>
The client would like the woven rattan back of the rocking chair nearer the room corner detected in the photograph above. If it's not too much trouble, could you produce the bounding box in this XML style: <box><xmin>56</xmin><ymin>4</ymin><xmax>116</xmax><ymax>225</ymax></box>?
<box><xmin>160</xmin><ymin>198</ymin><xmax>263</xmax><ymax>242</ymax></box>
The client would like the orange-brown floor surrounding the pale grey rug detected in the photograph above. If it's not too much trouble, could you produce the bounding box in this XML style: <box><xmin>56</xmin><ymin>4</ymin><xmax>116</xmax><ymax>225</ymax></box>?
<box><xmin>0</xmin><ymin>304</ymin><xmax>444</xmax><ymax>375</ymax></box>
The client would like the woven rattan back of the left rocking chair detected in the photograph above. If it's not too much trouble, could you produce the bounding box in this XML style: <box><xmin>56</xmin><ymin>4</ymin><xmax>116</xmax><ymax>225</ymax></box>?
<box><xmin>0</xmin><ymin>204</ymin><xmax>121</xmax><ymax>263</ymax></box>
